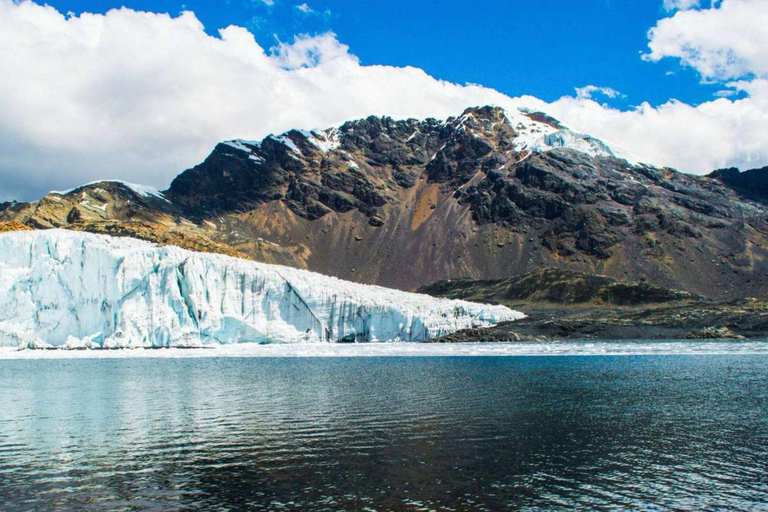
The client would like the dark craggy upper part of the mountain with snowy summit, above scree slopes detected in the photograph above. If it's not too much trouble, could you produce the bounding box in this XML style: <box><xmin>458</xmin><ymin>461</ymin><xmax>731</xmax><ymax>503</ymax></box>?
<box><xmin>169</xmin><ymin>106</ymin><xmax>648</xmax><ymax>223</ymax></box>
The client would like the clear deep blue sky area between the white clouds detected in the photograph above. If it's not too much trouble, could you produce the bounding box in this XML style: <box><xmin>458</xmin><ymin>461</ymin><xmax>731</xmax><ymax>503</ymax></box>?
<box><xmin>37</xmin><ymin>0</ymin><xmax>722</xmax><ymax>108</ymax></box>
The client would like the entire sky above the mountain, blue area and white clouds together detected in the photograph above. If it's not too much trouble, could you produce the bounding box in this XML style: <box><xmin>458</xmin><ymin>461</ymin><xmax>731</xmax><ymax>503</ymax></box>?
<box><xmin>0</xmin><ymin>0</ymin><xmax>768</xmax><ymax>200</ymax></box>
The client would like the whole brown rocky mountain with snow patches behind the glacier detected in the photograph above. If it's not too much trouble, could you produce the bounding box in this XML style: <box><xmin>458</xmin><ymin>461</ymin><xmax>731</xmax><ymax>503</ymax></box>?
<box><xmin>0</xmin><ymin>107</ymin><xmax>768</xmax><ymax>299</ymax></box>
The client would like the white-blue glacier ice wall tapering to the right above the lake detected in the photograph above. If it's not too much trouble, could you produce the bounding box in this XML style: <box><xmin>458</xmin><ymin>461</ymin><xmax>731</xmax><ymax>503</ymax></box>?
<box><xmin>0</xmin><ymin>230</ymin><xmax>524</xmax><ymax>348</ymax></box>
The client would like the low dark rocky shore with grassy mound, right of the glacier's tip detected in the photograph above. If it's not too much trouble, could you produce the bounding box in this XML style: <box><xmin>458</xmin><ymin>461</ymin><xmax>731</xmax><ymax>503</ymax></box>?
<box><xmin>420</xmin><ymin>269</ymin><xmax>768</xmax><ymax>343</ymax></box>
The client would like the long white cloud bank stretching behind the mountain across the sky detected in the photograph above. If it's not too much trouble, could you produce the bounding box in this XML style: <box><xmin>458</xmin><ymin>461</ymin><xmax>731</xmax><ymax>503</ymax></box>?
<box><xmin>0</xmin><ymin>0</ymin><xmax>768</xmax><ymax>200</ymax></box>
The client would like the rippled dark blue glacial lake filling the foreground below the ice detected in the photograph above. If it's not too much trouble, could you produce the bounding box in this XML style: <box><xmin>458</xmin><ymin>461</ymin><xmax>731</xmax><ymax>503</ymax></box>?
<box><xmin>0</xmin><ymin>342</ymin><xmax>768</xmax><ymax>512</ymax></box>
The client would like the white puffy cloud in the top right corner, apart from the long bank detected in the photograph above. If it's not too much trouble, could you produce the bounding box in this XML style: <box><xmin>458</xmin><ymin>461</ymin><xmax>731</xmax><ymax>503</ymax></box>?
<box><xmin>644</xmin><ymin>0</ymin><xmax>768</xmax><ymax>81</ymax></box>
